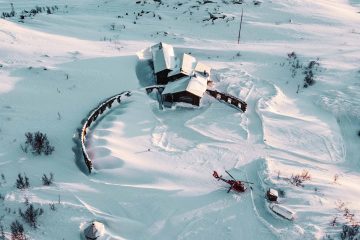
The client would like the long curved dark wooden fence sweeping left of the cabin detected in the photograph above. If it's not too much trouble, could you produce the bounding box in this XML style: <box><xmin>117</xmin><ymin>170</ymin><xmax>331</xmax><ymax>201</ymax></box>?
<box><xmin>80</xmin><ymin>91</ymin><xmax>131</xmax><ymax>173</ymax></box>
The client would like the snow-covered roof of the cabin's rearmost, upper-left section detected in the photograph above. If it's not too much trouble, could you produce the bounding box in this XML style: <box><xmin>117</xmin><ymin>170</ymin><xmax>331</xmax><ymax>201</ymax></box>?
<box><xmin>151</xmin><ymin>42</ymin><xmax>175</xmax><ymax>73</ymax></box>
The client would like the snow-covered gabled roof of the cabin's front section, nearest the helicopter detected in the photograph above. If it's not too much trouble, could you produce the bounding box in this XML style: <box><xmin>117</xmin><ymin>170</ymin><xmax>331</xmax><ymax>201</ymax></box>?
<box><xmin>162</xmin><ymin>75</ymin><xmax>207</xmax><ymax>97</ymax></box>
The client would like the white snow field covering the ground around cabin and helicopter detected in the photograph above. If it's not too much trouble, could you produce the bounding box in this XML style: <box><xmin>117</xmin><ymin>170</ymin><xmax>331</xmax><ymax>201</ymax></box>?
<box><xmin>0</xmin><ymin>0</ymin><xmax>360</xmax><ymax>240</ymax></box>
